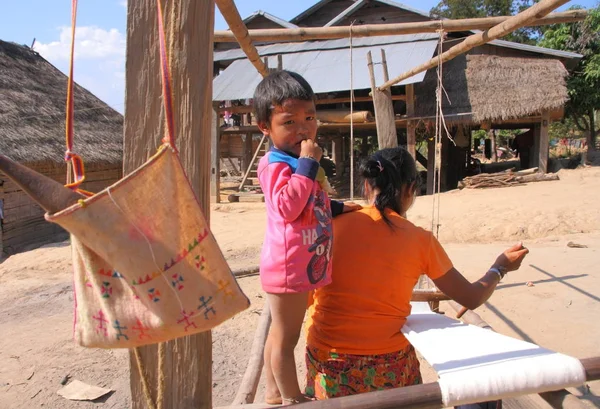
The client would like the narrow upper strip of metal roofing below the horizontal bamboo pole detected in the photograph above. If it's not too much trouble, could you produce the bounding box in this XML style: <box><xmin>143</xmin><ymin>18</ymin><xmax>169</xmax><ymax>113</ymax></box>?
<box><xmin>213</xmin><ymin>33</ymin><xmax>438</xmax><ymax>61</ymax></box>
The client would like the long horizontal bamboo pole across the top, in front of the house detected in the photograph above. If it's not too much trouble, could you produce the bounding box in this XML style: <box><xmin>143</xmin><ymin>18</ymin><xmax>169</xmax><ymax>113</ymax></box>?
<box><xmin>214</xmin><ymin>10</ymin><xmax>587</xmax><ymax>43</ymax></box>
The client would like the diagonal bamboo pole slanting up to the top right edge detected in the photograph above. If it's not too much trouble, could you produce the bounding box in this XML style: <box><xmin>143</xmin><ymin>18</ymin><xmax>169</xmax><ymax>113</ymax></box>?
<box><xmin>379</xmin><ymin>0</ymin><xmax>569</xmax><ymax>91</ymax></box>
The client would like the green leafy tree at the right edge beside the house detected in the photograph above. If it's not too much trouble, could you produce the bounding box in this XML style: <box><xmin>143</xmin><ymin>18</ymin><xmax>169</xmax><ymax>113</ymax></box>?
<box><xmin>538</xmin><ymin>3</ymin><xmax>600</xmax><ymax>150</ymax></box>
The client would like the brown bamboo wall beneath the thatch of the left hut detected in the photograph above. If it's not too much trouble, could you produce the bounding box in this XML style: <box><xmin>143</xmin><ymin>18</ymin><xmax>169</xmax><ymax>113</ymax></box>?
<box><xmin>0</xmin><ymin>163</ymin><xmax>123</xmax><ymax>256</ymax></box>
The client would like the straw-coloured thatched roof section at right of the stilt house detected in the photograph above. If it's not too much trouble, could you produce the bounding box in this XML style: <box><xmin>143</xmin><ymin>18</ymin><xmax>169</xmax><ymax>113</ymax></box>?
<box><xmin>415</xmin><ymin>55</ymin><xmax>568</xmax><ymax>123</ymax></box>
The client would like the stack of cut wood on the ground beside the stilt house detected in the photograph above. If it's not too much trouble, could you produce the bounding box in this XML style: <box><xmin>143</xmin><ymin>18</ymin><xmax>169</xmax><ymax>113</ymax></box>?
<box><xmin>458</xmin><ymin>168</ymin><xmax>559</xmax><ymax>189</ymax></box>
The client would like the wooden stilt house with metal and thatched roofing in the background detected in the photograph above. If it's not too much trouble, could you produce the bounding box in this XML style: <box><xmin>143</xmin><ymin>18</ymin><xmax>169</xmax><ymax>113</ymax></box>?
<box><xmin>213</xmin><ymin>0</ymin><xmax>581</xmax><ymax>199</ymax></box>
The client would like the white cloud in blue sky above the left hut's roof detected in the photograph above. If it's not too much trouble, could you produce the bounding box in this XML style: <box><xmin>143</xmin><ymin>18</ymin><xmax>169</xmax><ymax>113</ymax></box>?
<box><xmin>34</xmin><ymin>26</ymin><xmax>126</xmax><ymax>112</ymax></box>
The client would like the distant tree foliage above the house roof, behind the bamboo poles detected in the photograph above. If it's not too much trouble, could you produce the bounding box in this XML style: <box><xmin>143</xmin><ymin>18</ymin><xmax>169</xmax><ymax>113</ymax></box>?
<box><xmin>429</xmin><ymin>0</ymin><xmax>542</xmax><ymax>44</ymax></box>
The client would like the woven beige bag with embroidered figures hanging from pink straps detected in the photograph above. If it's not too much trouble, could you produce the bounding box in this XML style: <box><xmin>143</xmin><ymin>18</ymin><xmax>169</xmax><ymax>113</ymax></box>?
<box><xmin>46</xmin><ymin>0</ymin><xmax>250</xmax><ymax>348</ymax></box>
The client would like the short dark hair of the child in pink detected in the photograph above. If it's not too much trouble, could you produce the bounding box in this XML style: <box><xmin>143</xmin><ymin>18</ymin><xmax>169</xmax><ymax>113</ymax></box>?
<box><xmin>253</xmin><ymin>70</ymin><xmax>315</xmax><ymax>124</ymax></box>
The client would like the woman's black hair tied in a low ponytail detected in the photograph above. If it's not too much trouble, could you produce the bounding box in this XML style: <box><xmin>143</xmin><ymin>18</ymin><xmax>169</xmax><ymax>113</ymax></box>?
<box><xmin>360</xmin><ymin>147</ymin><xmax>420</xmax><ymax>226</ymax></box>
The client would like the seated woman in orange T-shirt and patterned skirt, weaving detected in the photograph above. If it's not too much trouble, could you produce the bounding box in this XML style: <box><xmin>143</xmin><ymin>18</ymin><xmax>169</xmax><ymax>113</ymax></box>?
<box><xmin>306</xmin><ymin>148</ymin><xmax>528</xmax><ymax>399</ymax></box>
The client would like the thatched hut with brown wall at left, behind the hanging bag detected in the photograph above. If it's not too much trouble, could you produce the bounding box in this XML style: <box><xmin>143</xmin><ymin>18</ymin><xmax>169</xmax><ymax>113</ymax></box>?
<box><xmin>0</xmin><ymin>41</ymin><xmax>123</xmax><ymax>255</ymax></box>
